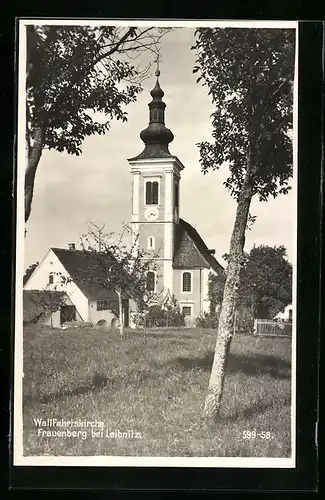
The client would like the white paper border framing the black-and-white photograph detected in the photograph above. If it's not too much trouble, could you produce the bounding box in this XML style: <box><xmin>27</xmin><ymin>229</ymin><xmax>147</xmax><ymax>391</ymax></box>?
<box><xmin>13</xmin><ymin>18</ymin><xmax>299</xmax><ymax>468</ymax></box>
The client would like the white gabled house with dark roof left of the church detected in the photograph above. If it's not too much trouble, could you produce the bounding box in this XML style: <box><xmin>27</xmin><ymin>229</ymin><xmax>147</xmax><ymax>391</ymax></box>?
<box><xmin>24</xmin><ymin>244</ymin><xmax>129</xmax><ymax>326</ymax></box>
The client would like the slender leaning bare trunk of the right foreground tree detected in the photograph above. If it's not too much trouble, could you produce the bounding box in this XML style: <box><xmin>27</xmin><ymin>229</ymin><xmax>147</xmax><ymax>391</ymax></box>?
<box><xmin>203</xmin><ymin>170</ymin><xmax>253</xmax><ymax>423</ymax></box>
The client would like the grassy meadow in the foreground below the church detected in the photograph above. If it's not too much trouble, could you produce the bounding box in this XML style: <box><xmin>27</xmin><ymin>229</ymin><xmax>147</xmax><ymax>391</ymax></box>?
<box><xmin>23</xmin><ymin>326</ymin><xmax>291</xmax><ymax>457</ymax></box>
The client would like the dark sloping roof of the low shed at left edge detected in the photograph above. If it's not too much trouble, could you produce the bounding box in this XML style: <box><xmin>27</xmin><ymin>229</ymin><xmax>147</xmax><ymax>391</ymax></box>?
<box><xmin>23</xmin><ymin>290</ymin><xmax>68</xmax><ymax>323</ymax></box>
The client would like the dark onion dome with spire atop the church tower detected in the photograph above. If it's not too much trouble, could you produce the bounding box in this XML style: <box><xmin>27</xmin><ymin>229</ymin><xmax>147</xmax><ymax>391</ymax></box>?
<box><xmin>132</xmin><ymin>69</ymin><xmax>174</xmax><ymax>159</ymax></box>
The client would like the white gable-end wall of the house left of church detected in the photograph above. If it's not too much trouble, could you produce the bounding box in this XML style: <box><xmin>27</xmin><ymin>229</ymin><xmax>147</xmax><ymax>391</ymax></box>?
<box><xmin>24</xmin><ymin>249</ymin><xmax>89</xmax><ymax>321</ymax></box>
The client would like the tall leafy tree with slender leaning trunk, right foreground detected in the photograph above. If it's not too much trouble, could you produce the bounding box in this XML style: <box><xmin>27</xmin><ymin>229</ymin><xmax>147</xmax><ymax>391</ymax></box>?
<box><xmin>193</xmin><ymin>28</ymin><xmax>295</xmax><ymax>422</ymax></box>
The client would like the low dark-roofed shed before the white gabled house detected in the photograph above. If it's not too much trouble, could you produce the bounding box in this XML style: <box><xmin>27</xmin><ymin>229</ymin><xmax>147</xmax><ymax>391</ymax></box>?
<box><xmin>23</xmin><ymin>290</ymin><xmax>81</xmax><ymax>328</ymax></box>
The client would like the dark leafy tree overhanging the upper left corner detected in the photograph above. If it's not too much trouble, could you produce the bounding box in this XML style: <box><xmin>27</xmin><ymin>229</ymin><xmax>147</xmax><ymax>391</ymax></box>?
<box><xmin>25</xmin><ymin>25</ymin><xmax>167</xmax><ymax>222</ymax></box>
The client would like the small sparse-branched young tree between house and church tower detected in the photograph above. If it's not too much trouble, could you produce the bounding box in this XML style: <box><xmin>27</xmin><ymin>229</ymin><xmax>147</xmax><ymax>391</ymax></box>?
<box><xmin>77</xmin><ymin>223</ymin><xmax>157</xmax><ymax>336</ymax></box>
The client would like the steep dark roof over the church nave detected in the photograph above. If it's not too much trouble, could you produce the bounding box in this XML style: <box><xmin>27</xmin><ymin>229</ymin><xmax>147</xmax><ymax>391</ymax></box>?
<box><xmin>173</xmin><ymin>219</ymin><xmax>223</xmax><ymax>272</ymax></box>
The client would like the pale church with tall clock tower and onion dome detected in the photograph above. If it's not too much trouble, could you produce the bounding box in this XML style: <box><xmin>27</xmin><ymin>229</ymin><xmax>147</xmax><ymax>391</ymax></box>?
<box><xmin>128</xmin><ymin>70</ymin><xmax>223</xmax><ymax>323</ymax></box>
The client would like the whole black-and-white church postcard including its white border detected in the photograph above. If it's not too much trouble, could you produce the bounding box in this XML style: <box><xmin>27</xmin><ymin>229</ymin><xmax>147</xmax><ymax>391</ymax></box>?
<box><xmin>13</xmin><ymin>19</ymin><xmax>298</xmax><ymax>468</ymax></box>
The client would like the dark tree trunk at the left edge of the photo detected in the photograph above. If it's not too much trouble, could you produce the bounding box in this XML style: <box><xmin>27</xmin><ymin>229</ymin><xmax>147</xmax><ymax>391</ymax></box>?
<box><xmin>25</xmin><ymin>126</ymin><xmax>44</xmax><ymax>222</ymax></box>
